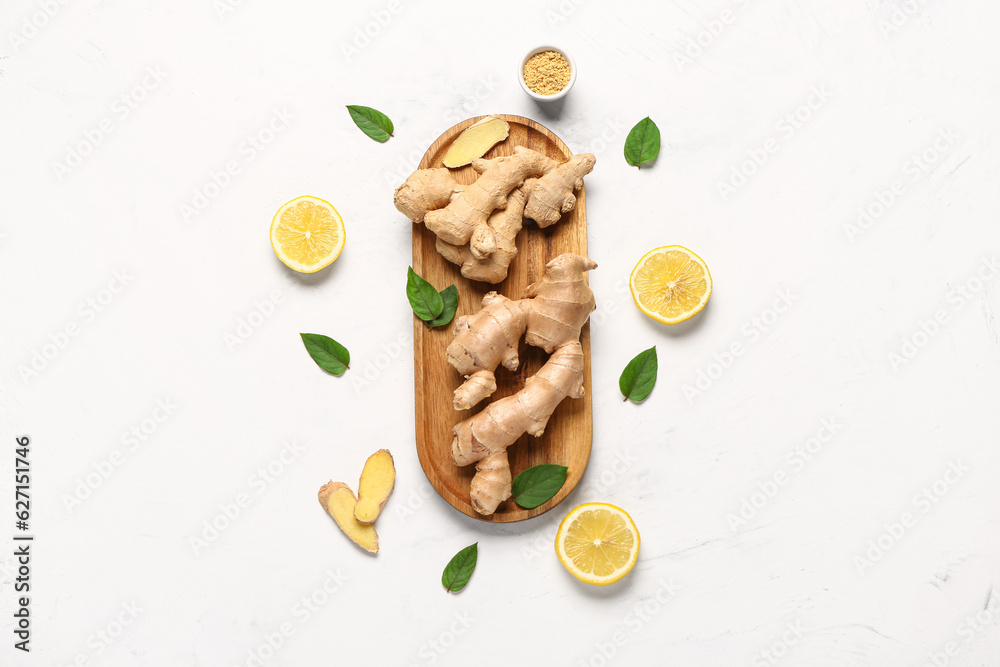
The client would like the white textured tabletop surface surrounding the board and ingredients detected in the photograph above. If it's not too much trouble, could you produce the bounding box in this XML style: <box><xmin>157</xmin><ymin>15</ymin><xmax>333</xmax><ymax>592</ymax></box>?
<box><xmin>0</xmin><ymin>0</ymin><xmax>1000</xmax><ymax>667</ymax></box>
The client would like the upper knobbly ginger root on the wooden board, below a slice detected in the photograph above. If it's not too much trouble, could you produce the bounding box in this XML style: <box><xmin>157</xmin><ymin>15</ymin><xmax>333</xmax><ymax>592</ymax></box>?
<box><xmin>394</xmin><ymin>142</ymin><xmax>596</xmax><ymax>284</ymax></box>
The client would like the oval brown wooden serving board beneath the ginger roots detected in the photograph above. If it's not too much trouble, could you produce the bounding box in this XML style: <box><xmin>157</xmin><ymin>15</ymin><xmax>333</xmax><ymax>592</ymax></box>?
<box><xmin>413</xmin><ymin>115</ymin><xmax>593</xmax><ymax>522</ymax></box>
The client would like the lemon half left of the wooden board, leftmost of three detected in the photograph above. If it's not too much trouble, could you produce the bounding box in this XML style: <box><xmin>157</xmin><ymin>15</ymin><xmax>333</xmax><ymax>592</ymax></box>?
<box><xmin>271</xmin><ymin>195</ymin><xmax>347</xmax><ymax>273</ymax></box>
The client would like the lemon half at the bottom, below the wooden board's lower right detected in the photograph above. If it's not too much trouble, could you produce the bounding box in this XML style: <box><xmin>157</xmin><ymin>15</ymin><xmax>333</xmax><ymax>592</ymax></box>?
<box><xmin>556</xmin><ymin>503</ymin><xmax>639</xmax><ymax>586</ymax></box>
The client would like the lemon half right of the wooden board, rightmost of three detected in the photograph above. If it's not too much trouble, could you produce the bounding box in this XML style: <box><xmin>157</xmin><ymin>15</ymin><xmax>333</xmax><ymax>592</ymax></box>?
<box><xmin>629</xmin><ymin>245</ymin><xmax>712</xmax><ymax>324</ymax></box>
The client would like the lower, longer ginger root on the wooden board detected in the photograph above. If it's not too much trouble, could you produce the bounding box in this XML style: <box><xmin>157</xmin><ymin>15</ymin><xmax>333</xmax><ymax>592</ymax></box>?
<box><xmin>446</xmin><ymin>253</ymin><xmax>597</xmax><ymax>515</ymax></box>
